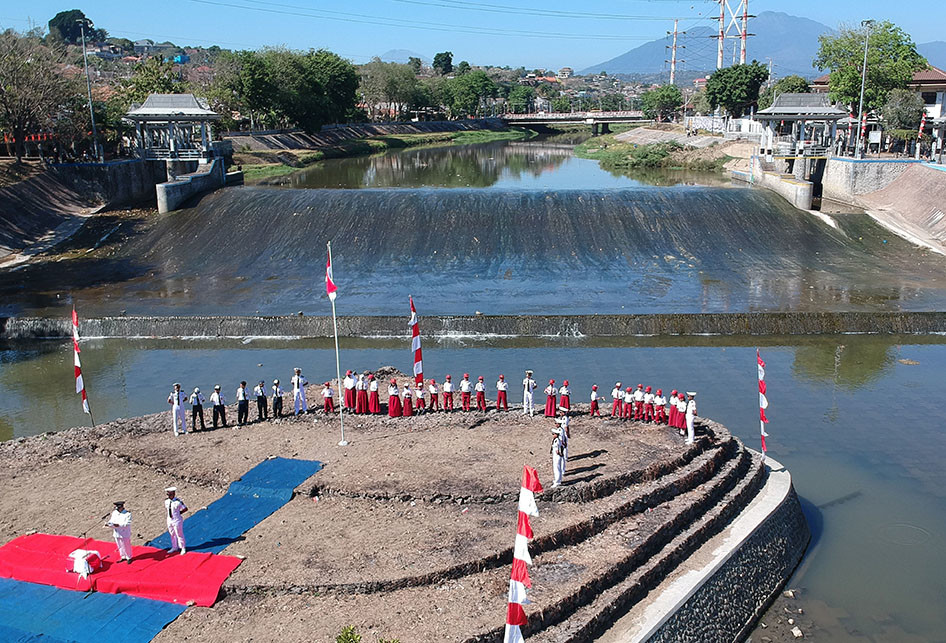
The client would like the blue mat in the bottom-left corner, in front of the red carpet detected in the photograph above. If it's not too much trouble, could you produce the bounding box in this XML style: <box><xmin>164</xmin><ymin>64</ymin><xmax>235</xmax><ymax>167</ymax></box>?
<box><xmin>0</xmin><ymin>578</ymin><xmax>187</xmax><ymax>643</ymax></box>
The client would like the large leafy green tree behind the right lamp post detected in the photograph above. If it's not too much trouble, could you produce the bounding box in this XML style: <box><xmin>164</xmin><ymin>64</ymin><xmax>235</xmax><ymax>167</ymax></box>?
<box><xmin>813</xmin><ymin>20</ymin><xmax>928</xmax><ymax>110</ymax></box>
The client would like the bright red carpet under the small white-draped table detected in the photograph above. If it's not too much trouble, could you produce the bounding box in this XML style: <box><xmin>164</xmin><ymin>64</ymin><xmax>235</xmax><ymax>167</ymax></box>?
<box><xmin>0</xmin><ymin>534</ymin><xmax>242</xmax><ymax>607</ymax></box>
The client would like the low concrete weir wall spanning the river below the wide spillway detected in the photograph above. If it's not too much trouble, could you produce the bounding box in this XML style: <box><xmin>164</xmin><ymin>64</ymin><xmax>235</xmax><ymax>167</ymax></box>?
<box><xmin>0</xmin><ymin>312</ymin><xmax>946</xmax><ymax>340</ymax></box>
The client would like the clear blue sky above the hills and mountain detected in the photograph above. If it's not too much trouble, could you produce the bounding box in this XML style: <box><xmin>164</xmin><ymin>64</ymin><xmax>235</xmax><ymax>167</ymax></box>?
<box><xmin>0</xmin><ymin>0</ymin><xmax>946</xmax><ymax>69</ymax></box>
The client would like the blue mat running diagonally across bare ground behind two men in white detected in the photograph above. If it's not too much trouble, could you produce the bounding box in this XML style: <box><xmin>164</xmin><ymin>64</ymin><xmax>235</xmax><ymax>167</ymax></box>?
<box><xmin>147</xmin><ymin>458</ymin><xmax>322</xmax><ymax>554</ymax></box>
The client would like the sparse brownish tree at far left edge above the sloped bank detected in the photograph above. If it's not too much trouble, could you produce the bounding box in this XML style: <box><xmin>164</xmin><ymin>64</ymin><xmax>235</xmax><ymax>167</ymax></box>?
<box><xmin>0</xmin><ymin>30</ymin><xmax>84</xmax><ymax>162</ymax></box>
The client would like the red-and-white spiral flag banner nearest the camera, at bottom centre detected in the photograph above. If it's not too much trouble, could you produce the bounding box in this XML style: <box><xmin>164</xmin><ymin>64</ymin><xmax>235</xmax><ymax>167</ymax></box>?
<box><xmin>503</xmin><ymin>467</ymin><xmax>542</xmax><ymax>643</ymax></box>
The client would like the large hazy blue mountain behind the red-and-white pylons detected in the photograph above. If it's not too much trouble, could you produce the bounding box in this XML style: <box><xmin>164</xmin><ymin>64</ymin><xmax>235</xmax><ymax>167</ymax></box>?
<box><xmin>581</xmin><ymin>11</ymin><xmax>832</xmax><ymax>78</ymax></box>
